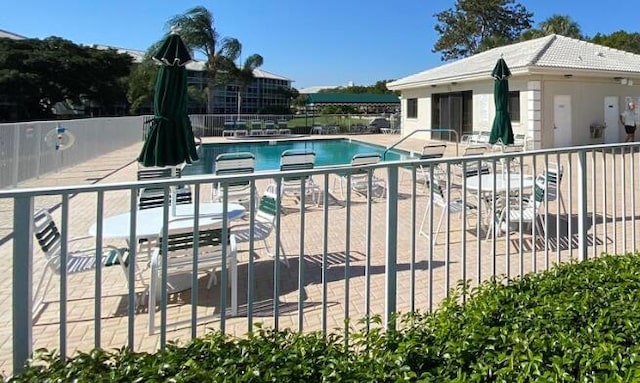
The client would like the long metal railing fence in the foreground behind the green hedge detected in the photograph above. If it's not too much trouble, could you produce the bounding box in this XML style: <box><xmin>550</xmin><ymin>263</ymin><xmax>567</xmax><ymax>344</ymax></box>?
<box><xmin>0</xmin><ymin>144</ymin><xmax>640</xmax><ymax>371</ymax></box>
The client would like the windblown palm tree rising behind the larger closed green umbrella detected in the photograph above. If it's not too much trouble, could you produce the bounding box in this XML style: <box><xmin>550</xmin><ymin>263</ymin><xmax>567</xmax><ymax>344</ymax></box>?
<box><xmin>168</xmin><ymin>6</ymin><xmax>241</xmax><ymax>113</ymax></box>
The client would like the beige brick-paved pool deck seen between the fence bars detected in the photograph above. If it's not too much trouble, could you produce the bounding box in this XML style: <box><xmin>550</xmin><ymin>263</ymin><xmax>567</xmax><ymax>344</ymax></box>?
<box><xmin>0</xmin><ymin>135</ymin><xmax>640</xmax><ymax>371</ymax></box>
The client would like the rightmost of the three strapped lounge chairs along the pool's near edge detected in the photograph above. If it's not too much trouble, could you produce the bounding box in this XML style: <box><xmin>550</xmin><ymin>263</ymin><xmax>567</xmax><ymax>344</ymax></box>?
<box><xmin>333</xmin><ymin>153</ymin><xmax>387</xmax><ymax>198</ymax></box>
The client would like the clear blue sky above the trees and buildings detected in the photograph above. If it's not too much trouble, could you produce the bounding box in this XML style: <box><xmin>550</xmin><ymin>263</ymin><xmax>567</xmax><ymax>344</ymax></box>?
<box><xmin>0</xmin><ymin>0</ymin><xmax>640</xmax><ymax>89</ymax></box>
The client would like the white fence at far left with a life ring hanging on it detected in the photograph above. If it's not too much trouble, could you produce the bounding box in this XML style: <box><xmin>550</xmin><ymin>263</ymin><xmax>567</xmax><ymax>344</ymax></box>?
<box><xmin>0</xmin><ymin>116</ymin><xmax>143</xmax><ymax>188</ymax></box>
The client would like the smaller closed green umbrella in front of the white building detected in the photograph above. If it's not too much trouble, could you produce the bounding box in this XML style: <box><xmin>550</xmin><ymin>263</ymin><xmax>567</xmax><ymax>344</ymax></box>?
<box><xmin>489</xmin><ymin>57</ymin><xmax>513</xmax><ymax>145</ymax></box>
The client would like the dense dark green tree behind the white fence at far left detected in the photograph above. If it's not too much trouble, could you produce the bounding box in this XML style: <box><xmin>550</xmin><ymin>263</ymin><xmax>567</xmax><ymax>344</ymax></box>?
<box><xmin>0</xmin><ymin>37</ymin><xmax>132</xmax><ymax>120</ymax></box>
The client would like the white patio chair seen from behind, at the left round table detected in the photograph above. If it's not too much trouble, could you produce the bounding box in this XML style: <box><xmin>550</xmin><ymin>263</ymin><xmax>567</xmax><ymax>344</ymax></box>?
<box><xmin>148</xmin><ymin>221</ymin><xmax>238</xmax><ymax>335</ymax></box>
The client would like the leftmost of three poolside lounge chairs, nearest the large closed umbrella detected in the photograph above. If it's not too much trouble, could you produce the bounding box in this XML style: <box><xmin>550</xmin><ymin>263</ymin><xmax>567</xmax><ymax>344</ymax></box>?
<box><xmin>211</xmin><ymin>152</ymin><xmax>256</xmax><ymax>208</ymax></box>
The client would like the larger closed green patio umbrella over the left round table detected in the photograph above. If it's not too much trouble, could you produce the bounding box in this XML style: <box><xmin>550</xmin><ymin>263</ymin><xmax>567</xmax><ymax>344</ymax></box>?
<box><xmin>138</xmin><ymin>32</ymin><xmax>198</xmax><ymax>166</ymax></box>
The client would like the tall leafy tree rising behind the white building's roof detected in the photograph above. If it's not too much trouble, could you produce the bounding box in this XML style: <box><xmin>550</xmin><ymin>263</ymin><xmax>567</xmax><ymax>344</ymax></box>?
<box><xmin>433</xmin><ymin>0</ymin><xmax>533</xmax><ymax>61</ymax></box>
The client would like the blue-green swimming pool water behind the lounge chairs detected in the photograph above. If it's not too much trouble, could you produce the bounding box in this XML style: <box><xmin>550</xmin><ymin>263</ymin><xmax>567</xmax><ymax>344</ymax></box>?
<box><xmin>183</xmin><ymin>139</ymin><xmax>418</xmax><ymax>175</ymax></box>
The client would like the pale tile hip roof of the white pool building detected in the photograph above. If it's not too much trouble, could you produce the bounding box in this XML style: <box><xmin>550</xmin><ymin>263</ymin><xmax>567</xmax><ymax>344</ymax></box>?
<box><xmin>387</xmin><ymin>35</ymin><xmax>640</xmax><ymax>90</ymax></box>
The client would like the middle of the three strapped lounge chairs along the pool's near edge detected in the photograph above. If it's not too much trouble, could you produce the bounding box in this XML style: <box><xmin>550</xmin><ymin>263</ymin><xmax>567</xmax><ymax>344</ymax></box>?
<box><xmin>266</xmin><ymin>149</ymin><xmax>320</xmax><ymax>206</ymax></box>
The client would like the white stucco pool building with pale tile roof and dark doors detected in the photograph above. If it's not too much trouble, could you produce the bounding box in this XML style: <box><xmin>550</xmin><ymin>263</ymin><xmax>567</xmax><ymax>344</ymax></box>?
<box><xmin>387</xmin><ymin>35</ymin><xmax>640</xmax><ymax>148</ymax></box>
